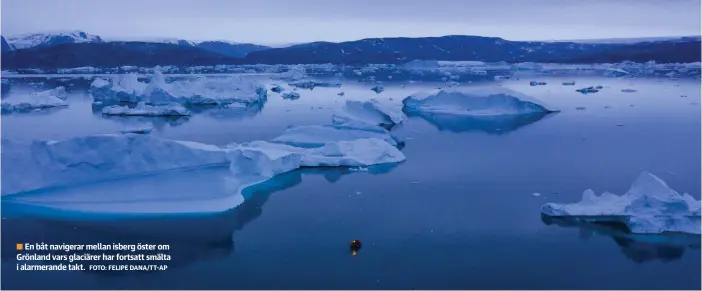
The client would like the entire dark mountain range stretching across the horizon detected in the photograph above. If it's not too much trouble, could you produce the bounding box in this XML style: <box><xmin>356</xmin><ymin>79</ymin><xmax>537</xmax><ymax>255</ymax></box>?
<box><xmin>2</xmin><ymin>35</ymin><xmax>701</xmax><ymax>68</ymax></box>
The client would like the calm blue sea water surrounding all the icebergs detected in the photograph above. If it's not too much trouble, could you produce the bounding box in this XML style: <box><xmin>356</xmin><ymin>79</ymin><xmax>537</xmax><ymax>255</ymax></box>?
<box><xmin>2</xmin><ymin>76</ymin><xmax>701</xmax><ymax>289</ymax></box>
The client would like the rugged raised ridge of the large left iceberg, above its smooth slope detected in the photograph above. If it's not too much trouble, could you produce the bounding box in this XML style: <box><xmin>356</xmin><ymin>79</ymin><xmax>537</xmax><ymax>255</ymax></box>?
<box><xmin>0</xmin><ymin>134</ymin><xmax>229</xmax><ymax>195</ymax></box>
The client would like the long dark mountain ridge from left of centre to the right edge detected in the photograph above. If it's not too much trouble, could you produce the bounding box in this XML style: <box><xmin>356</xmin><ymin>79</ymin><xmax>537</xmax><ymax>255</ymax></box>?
<box><xmin>244</xmin><ymin>35</ymin><xmax>700</xmax><ymax>64</ymax></box>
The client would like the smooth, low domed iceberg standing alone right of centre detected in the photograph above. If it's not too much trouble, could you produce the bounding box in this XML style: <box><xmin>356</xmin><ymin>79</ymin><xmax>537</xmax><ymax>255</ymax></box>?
<box><xmin>402</xmin><ymin>87</ymin><xmax>556</xmax><ymax>116</ymax></box>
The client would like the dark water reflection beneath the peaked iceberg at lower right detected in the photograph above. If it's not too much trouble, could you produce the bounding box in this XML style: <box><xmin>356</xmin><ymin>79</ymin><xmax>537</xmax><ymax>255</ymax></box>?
<box><xmin>541</xmin><ymin>215</ymin><xmax>700</xmax><ymax>263</ymax></box>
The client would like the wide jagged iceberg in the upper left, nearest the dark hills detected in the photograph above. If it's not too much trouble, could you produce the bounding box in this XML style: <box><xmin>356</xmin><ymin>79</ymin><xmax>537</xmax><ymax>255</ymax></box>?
<box><xmin>90</xmin><ymin>70</ymin><xmax>267</xmax><ymax>106</ymax></box>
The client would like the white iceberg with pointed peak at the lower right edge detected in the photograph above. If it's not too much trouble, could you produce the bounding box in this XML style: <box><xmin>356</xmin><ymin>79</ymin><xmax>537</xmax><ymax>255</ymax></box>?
<box><xmin>541</xmin><ymin>172</ymin><xmax>700</xmax><ymax>234</ymax></box>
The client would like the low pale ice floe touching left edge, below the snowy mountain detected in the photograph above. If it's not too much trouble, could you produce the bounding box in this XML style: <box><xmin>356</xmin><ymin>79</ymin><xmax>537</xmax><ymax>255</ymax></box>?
<box><xmin>1</xmin><ymin>87</ymin><xmax>68</xmax><ymax>113</ymax></box>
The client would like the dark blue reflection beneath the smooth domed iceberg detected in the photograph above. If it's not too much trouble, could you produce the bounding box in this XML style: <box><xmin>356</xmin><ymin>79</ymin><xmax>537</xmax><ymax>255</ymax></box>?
<box><xmin>405</xmin><ymin>111</ymin><xmax>557</xmax><ymax>134</ymax></box>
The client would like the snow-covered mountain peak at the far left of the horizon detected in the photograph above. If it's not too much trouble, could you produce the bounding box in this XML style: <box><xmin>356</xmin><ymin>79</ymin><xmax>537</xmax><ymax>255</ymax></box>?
<box><xmin>7</xmin><ymin>30</ymin><xmax>103</xmax><ymax>49</ymax></box>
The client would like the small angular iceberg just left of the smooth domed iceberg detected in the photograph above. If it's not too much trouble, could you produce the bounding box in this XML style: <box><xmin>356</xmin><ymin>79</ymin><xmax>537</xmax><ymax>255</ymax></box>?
<box><xmin>335</xmin><ymin>99</ymin><xmax>405</xmax><ymax>127</ymax></box>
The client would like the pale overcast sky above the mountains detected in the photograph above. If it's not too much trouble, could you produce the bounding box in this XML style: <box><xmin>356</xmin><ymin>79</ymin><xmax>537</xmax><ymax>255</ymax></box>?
<box><xmin>1</xmin><ymin>0</ymin><xmax>700</xmax><ymax>44</ymax></box>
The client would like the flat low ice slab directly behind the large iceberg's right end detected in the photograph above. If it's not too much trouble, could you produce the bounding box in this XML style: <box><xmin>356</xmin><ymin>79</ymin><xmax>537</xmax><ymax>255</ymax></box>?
<box><xmin>272</xmin><ymin>122</ymin><xmax>400</xmax><ymax>147</ymax></box>
